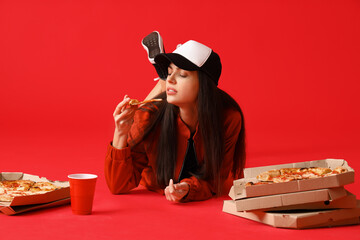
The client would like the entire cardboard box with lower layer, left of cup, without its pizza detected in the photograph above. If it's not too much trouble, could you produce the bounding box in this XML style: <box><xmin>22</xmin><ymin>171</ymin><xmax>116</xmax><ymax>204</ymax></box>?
<box><xmin>0</xmin><ymin>172</ymin><xmax>70</xmax><ymax>215</ymax></box>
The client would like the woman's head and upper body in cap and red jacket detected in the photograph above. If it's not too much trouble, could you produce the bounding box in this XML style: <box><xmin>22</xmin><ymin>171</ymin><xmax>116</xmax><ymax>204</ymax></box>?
<box><xmin>105</xmin><ymin>40</ymin><xmax>245</xmax><ymax>202</ymax></box>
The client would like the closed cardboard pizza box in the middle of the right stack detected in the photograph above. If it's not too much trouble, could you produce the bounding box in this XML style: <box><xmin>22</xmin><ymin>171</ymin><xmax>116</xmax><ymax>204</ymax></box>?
<box><xmin>235</xmin><ymin>187</ymin><xmax>356</xmax><ymax>211</ymax></box>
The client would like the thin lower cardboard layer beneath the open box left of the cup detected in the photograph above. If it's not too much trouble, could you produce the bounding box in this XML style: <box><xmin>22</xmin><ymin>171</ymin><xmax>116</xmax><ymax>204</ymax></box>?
<box><xmin>0</xmin><ymin>197</ymin><xmax>70</xmax><ymax>216</ymax></box>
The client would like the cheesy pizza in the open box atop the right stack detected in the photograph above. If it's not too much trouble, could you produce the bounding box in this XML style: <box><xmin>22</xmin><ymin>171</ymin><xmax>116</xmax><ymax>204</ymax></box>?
<box><xmin>246</xmin><ymin>166</ymin><xmax>348</xmax><ymax>186</ymax></box>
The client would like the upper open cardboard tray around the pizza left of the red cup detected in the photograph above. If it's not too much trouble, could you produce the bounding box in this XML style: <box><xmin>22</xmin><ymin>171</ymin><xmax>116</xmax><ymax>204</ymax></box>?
<box><xmin>0</xmin><ymin>172</ymin><xmax>70</xmax><ymax>207</ymax></box>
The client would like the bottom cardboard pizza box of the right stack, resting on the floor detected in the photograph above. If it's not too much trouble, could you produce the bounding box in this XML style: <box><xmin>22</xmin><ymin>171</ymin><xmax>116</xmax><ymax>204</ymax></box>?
<box><xmin>223</xmin><ymin>200</ymin><xmax>360</xmax><ymax>229</ymax></box>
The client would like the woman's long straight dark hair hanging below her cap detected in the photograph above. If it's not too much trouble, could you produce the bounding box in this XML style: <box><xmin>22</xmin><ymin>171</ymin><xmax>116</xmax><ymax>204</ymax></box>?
<box><xmin>135</xmin><ymin>71</ymin><xmax>246</xmax><ymax>195</ymax></box>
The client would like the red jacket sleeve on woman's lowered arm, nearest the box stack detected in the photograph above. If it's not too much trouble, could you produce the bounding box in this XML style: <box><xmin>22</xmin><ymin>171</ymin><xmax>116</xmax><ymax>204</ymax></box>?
<box><xmin>181</xmin><ymin>111</ymin><xmax>241</xmax><ymax>202</ymax></box>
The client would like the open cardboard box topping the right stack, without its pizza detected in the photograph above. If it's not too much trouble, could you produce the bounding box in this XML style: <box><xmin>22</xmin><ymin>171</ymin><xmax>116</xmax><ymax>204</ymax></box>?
<box><xmin>231</xmin><ymin>159</ymin><xmax>355</xmax><ymax>199</ymax></box>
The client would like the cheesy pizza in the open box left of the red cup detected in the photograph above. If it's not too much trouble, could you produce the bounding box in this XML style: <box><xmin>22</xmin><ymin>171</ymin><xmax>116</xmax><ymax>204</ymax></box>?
<box><xmin>0</xmin><ymin>180</ymin><xmax>61</xmax><ymax>202</ymax></box>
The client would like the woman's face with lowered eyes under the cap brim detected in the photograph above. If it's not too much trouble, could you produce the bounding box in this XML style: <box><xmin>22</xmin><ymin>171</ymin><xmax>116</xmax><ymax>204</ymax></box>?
<box><xmin>166</xmin><ymin>63</ymin><xmax>199</xmax><ymax>108</ymax></box>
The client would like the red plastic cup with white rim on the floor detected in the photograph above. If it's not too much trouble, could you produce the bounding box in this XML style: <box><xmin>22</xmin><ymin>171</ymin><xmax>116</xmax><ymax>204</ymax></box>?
<box><xmin>68</xmin><ymin>173</ymin><xmax>97</xmax><ymax>215</ymax></box>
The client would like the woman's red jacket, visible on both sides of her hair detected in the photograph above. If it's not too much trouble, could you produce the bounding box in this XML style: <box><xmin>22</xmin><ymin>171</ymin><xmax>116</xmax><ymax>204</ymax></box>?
<box><xmin>105</xmin><ymin>110</ymin><xmax>241</xmax><ymax>201</ymax></box>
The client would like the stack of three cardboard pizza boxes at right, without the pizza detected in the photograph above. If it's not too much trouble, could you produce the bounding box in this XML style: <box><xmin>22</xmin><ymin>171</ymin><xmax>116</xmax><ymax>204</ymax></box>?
<box><xmin>223</xmin><ymin>159</ymin><xmax>360</xmax><ymax>229</ymax></box>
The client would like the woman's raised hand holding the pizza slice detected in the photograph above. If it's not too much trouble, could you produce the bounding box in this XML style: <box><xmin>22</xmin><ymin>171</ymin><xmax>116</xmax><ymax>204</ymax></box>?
<box><xmin>112</xmin><ymin>95</ymin><xmax>138</xmax><ymax>149</ymax></box>
